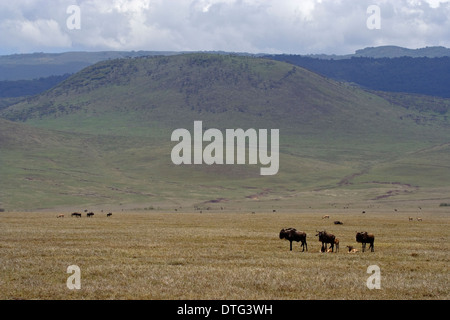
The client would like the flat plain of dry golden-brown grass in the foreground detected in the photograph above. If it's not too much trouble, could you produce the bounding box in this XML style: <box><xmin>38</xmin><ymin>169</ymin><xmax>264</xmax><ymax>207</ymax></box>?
<box><xmin>0</xmin><ymin>206</ymin><xmax>450</xmax><ymax>300</ymax></box>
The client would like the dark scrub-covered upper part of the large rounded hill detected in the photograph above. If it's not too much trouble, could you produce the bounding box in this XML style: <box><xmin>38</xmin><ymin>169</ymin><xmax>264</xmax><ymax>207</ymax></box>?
<box><xmin>2</xmin><ymin>54</ymin><xmax>428</xmax><ymax>135</ymax></box>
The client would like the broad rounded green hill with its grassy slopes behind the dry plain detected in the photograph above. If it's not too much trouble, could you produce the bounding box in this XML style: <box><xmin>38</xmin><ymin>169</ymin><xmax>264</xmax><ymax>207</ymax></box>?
<box><xmin>0</xmin><ymin>54</ymin><xmax>450</xmax><ymax>209</ymax></box>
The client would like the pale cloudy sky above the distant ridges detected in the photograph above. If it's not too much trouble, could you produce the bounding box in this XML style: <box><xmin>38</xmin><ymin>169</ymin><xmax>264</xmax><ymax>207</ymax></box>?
<box><xmin>0</xmin><ymin>0</ymin><xmax>450</xmax><ymax>55</ymax></box>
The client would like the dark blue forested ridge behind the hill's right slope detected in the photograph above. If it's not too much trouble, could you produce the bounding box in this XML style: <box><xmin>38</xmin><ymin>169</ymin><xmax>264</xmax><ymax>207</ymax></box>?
<box><xmin>267</xmin><ymin>55</ymin><xmax>450</xmax><ymax>98</ymax></box>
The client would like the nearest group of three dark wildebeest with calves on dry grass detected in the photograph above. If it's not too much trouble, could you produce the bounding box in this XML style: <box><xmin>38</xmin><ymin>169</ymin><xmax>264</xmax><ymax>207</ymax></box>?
<box><xmin>280</xmin><ymin>215</ymin><xmax>375</xmax><ymax>253</ymax></box>
